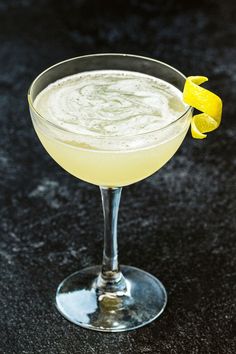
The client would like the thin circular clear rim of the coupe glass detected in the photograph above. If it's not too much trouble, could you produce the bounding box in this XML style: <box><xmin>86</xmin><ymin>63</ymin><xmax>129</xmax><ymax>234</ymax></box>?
<box><xmin>27</xmin><ymin>53</ymin><xmax>193</xmax><ymax>139</ymax></box>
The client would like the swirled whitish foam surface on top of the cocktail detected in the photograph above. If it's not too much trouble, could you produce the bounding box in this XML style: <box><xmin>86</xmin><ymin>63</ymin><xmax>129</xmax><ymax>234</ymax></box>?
<box><xmin>34</xmin><ymin>70</ymin><xmax>186</xmax><ymax>141</ymax></box>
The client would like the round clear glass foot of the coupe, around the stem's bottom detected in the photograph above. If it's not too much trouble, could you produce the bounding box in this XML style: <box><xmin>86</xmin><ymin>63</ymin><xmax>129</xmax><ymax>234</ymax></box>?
<box><xmin>56</xmin><ymin>266</ymin><xmax>167</xmax><ymax>332</ymax></box>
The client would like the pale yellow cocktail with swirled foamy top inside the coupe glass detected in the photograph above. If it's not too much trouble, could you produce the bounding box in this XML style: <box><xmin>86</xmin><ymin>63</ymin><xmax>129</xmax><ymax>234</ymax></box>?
<box><xmin>34</xmin><ymin>70</ymin><xmax>191</xmax><ymax>187</ymax></box>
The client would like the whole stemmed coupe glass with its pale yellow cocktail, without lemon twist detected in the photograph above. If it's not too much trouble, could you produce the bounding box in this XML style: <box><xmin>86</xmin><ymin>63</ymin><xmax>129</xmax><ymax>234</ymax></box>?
<box><xmin>28</xmin><ymin>53</ymin><xmax>195</xmax><ymax>332</ymax></box>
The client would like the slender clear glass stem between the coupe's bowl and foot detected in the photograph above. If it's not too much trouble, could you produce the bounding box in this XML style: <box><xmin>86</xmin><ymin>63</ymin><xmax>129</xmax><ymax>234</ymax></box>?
<box><xmin>97</xmin><ymin>187</ymin><xmax>126</xmax><ymax>293</ymax></box>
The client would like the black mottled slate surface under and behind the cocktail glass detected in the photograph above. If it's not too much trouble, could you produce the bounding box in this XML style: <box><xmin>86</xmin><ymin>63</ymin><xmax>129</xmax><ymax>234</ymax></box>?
<box><xmin>0</xmin><ymin>0</ymin><xmax>236</xmax><ymax>354</ymax></box>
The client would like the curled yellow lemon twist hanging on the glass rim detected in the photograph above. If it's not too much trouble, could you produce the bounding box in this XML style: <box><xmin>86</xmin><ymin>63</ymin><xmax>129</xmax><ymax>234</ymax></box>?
<box><xmin>183</xmin><ymin>76</ymin><xmax>222</xmax><ymax>139</ymax></box>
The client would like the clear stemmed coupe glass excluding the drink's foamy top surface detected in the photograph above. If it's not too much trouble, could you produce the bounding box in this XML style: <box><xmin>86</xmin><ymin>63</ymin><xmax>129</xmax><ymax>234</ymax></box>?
<box><xmin>28</xmin><ymin>54</ymin><xmax>192</xmax><ymax>332</ymax></box>
